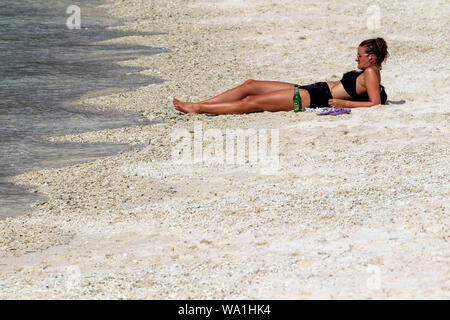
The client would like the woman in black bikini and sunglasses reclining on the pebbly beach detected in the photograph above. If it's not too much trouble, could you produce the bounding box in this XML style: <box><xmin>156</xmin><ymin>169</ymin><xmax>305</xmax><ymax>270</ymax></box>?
<box><xmin>173</xmin><ymin>38</ymin><xmax>389</xmax><ymax>114</ymax></box>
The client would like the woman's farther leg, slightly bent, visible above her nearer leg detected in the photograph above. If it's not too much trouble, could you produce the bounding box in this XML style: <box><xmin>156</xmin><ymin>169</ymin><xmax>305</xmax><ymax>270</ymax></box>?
<box><xmin>198</xmin><ymin>79</ymin><xmax>294</xmax><ymax>103</ymax></box>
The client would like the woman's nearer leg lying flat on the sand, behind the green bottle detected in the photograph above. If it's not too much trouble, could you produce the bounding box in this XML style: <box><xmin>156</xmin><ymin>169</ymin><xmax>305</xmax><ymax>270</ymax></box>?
<box><xmin>173</xmin><ymin>88</ymin><xmax>310</xmax><ymax>114</ymax></box>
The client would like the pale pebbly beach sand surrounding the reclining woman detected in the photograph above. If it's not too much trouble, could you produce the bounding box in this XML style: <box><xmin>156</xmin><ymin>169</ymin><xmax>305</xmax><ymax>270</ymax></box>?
<box><xmin>0</xmin><ymin>0</ymin><xmax>450</xmax><ymax>299</ymax></box>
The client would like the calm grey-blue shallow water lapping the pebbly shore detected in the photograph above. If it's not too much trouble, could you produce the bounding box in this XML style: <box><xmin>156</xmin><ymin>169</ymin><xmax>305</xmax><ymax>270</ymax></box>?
<box><xmin>0</xmin><ymin>0</ymin><xmax>168</xmax><ymax>219</ymax></box>
